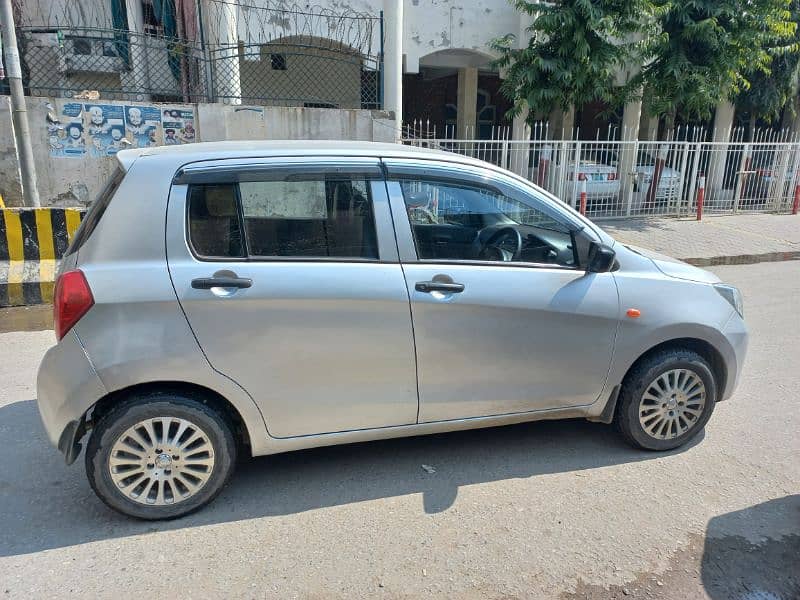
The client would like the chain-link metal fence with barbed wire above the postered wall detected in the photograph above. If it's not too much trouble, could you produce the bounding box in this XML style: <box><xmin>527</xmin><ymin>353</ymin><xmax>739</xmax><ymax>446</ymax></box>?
<box><xmin>18</xmin><ymin>0</ymin><xmax>383</xmax><ymax>109</ymax></box>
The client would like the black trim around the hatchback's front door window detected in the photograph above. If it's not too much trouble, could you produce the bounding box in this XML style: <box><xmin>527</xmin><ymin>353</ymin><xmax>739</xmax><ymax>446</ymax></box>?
<box><xmin>394</xmin><ymin>171</ymin><xmax>585</xmax><ymax>271</ymax></box>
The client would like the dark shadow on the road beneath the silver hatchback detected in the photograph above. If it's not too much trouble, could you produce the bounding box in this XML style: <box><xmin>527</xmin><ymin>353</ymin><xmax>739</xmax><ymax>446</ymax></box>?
<box><xmin>0</xmin><ymin>400</ymin><xmax>702</xmax><ymax>556</ymax></box>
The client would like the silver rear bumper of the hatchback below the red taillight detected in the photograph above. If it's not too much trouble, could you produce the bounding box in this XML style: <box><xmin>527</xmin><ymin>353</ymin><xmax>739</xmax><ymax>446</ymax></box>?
<box><xmin>36</xmin><ymin>331</ymin><xmax>106</xmax><ymax>462</ymax></box>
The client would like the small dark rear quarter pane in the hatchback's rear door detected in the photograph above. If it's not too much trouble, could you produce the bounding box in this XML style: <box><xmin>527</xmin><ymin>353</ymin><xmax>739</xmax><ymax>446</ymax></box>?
<box><xmin>189</xmin><ymin>184</ymin><xmax>245</xmax><ymax>258</ymax></box>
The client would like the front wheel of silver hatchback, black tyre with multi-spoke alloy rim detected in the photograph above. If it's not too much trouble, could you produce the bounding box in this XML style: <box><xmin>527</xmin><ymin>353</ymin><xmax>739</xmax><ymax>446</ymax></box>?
<box><xmin>615</xmin><ymin>349</ymin><xmax>717</xmax><ymax>451</ymax></box>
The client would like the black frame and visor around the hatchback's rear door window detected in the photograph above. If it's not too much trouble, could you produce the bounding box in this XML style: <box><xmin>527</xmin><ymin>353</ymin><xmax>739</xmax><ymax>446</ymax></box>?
<box><xmin>188</xmin><ymin>163</ymin><xmax>385</xmax><ymax>263</ymax></box>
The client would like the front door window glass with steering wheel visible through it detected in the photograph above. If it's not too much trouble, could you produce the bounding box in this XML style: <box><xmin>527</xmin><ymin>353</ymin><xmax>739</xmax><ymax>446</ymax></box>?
<box><xmin>399</xmin><ymin>179</ymin><xmax>577</xmax><ymax>267</ymax></box>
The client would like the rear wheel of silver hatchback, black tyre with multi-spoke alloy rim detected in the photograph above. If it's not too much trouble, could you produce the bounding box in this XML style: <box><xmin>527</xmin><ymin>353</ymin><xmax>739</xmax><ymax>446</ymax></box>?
<box><xmin>86</xmin><ymin>392</ymin><xmax>237</xmax><ymax>520</ymax></box>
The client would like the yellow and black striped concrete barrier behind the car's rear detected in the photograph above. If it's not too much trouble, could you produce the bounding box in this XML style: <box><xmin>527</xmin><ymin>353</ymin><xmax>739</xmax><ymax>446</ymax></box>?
<box><xmin>0</xmin><ymin>208</ymin><xmax>85</xmax><ymax>306</ymax></box>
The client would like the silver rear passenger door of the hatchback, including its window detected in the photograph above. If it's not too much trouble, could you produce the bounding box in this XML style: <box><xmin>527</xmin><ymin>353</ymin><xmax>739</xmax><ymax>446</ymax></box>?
<box><xmin>167</xmin><ymin>159</ymin><xmax>418</xmax><ymax>437</ymax></box>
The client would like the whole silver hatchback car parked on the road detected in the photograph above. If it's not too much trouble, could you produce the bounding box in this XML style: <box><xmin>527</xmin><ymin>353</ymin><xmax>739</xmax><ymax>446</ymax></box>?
<box><xmin>38</xmin><ymin>142</ymin><xmax>747</xmax><ymax>519</ymax></box>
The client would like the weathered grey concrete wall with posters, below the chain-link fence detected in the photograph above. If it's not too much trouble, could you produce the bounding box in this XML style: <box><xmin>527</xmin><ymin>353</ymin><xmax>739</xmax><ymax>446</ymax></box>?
<box><xmin>0</xmin><ymin>96</ymin><xmax>394</xmax><ymax>207</ymax></box>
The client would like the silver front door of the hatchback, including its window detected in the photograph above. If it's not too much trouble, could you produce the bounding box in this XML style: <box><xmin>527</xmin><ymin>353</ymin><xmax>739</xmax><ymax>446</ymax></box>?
<box><xmin>385</xmin><ymin>160</ymin><xmax>619</xmax><ymax>422</ymax></box>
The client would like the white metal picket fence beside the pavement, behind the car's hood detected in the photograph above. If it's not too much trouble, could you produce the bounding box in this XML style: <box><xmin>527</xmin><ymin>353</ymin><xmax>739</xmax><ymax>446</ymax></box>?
<box><xmin>403</xmin><ymin>129</ymin><xmax>800</xmax><ymax>218</ymax></box>
